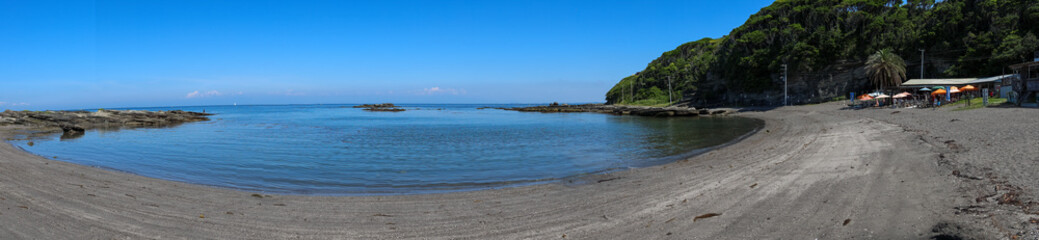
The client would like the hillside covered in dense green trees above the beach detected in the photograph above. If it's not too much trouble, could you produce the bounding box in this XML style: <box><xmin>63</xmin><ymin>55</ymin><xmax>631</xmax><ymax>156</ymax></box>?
<box><xmin>606</xmin><ymin>0</ymin><xmax>1039</xmax><ymax>106</ymax></box>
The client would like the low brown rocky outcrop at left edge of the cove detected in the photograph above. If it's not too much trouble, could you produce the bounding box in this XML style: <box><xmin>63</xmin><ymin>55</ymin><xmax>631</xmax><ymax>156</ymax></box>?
<box><xmin>0</xmin><ymin>109</ymin><xmax>212</xmax><ymax>135</ymax></box>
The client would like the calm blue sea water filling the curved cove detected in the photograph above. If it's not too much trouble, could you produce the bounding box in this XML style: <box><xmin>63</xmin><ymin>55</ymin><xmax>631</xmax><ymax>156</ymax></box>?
<box><xmin>11</xmin><ymin>105</ymin><xmax>763</xmax><ymax>195</ymax></box>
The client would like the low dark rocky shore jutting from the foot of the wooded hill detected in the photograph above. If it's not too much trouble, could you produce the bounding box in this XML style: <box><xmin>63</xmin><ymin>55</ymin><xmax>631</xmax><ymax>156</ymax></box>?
<box><xmin>501</xmin><ymin>103</ymin><xmax>736</xmax><ymax>117</ymax></box>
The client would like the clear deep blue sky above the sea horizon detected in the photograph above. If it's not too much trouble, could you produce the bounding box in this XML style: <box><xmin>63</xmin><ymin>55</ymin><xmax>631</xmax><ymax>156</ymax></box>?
<box><xmin>0</xmin><ymin>0</ymin><xmax>771</xmax><ymax>110</ymax></box>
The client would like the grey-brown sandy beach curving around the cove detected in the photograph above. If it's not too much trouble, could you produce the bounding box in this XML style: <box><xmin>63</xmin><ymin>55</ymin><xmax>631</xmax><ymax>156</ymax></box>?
<box><xmin>0</xmin><ymin>103</ymin><xmax>1039</xmax><ymax>239</ymax></box>
